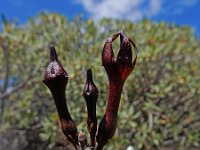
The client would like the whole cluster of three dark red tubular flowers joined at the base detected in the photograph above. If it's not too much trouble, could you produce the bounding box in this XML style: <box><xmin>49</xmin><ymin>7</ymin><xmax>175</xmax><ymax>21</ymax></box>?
<box><xmin>43</xmin><ymin>31</ymin><xmax>137</xmax><ymax>150</ymax></box>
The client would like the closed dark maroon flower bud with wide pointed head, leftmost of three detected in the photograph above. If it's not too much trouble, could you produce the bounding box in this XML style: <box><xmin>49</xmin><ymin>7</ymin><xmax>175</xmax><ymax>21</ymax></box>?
<box><xmin>43</xmin><ymin>44</ymin><xmax>78</xmax><ymax>146</ymax></box>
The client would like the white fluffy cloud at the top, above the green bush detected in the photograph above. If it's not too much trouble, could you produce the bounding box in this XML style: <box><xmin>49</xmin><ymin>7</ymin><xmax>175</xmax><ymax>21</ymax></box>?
<box><xmin>78</xmin><ymin>0</ymin><xmax>162</xmax><ymax>21</ymax></box>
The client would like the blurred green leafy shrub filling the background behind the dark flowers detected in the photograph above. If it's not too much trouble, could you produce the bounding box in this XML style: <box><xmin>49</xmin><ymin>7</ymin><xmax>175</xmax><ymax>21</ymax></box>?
<box><xmin>0</xmin><ymin>14</ymin><xmax>200</xmax><ymax>150</ymax></box>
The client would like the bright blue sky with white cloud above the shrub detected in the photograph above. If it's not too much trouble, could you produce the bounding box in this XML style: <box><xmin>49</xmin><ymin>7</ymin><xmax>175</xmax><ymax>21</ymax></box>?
<box><xmin>0</xmin><ymin>0</ymin><xmax>200</xmax><ymax>35</ymax></box>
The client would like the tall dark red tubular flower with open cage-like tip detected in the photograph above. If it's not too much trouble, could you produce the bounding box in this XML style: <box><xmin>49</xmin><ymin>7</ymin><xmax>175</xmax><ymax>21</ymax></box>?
<box><xmin>97</xmin><ymin>31</ymin><xmax>137</xmax><ymax>150</ymax></box>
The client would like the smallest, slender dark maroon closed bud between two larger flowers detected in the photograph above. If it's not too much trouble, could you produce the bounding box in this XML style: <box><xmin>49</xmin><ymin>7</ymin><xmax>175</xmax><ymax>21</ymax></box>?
<box><xmin>83</xmin><ymin>69</ymin><xmax>99</xmax><ymax>147</ymax></box>
